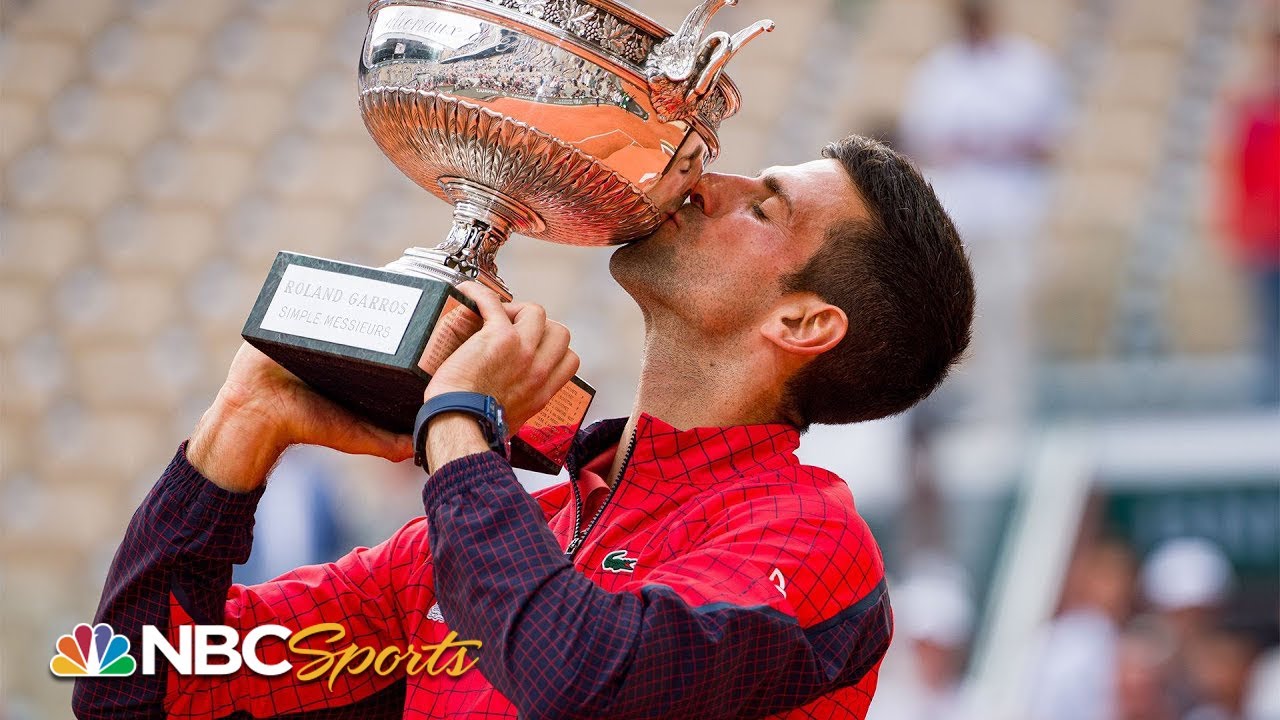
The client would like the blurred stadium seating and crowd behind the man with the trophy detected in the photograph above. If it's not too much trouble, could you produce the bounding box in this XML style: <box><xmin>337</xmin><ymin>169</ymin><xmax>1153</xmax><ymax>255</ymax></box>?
<box><xmin>0</xmin><ymin>0</ymin><xmax>1280</xmax><ymax>720</ymax></box>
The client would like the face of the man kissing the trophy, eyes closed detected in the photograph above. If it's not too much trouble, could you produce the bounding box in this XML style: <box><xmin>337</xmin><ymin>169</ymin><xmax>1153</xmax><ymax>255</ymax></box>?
<box><xmin>609</xmin><ymin>159</ymin><xmax>868</xmax><ymax>334</ymax></box>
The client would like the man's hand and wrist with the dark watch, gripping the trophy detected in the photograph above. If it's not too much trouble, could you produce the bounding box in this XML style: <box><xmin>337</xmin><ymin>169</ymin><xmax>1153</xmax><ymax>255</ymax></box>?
<box><xmin>424</xmin><ymin>282</ymin><xmax>579</xmax><ymax>471</ymax></box>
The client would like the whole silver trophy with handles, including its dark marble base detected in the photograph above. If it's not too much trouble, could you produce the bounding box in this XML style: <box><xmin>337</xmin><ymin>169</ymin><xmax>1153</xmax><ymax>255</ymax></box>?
<box><xmin>243</xmin><ymin>0</ymin><xmax>773</xmax><ymax>473</ymax></box>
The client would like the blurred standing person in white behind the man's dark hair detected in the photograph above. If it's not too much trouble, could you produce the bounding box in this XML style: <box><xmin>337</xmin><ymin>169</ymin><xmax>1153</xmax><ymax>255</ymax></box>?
<box><xmin>901</xmin><ymin>0</ymin><xmax>1068</xmax><ymax>421</ymax></box>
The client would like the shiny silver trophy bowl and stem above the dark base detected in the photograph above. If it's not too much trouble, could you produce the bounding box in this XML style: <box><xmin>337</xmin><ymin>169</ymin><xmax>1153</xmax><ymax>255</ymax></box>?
<box><xmin>360</xmin><ymin>0</ymin><xmax>773</xmax><ymax>293</ymax></box>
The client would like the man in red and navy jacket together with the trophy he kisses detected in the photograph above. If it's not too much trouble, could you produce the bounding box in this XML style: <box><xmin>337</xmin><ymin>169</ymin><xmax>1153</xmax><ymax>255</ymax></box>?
<box><xmin>73</xmin><ymin>0</ymin><xmax>974</xmax><ymax>719</ymax></box>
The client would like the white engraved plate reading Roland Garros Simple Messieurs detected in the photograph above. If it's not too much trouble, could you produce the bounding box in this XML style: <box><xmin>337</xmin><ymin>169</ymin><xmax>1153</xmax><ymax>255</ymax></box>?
<box><xmin>261</xmin><ymin>265</ymin><xmax>422</xmax><ymax>355</ymax></box>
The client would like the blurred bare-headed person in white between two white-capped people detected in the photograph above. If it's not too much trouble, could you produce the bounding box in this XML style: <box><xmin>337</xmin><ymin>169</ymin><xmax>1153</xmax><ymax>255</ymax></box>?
<box><xmin>1029</xmin><ymin>541</ymin><xmax>1135</xmax><ymax>720</ymax></box>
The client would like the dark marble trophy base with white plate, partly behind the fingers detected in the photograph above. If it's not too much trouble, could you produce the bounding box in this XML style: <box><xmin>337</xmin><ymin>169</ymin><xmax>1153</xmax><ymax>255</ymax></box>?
<box><xmin>242</xmin><ymin>252</ymin><xmax>595</xmax><ymax>474</ymax></box>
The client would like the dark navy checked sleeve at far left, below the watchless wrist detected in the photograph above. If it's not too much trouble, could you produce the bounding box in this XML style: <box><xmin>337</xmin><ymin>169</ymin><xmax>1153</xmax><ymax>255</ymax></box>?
<box><xmin>72</xmin><ymin>443</ymin><xmax>262</xmax><ymax>720</ymax></box>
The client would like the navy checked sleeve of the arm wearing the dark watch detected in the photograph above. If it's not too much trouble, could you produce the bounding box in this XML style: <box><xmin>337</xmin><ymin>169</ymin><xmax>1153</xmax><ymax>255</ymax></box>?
<box><xmin>422</xmin><ymin>452</ymin><xmax>891</xmax><ymax>719</ymax></box>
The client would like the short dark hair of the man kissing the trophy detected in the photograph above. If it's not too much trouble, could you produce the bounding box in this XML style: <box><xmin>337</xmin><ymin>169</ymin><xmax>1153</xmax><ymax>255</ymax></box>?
<box><xmin>782</xmin><ymin>135</ymin><xmax>974</xmax><ymax>429</ymax></box>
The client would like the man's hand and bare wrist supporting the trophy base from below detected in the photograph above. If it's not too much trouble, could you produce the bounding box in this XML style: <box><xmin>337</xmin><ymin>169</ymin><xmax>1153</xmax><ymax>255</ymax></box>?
<box><xmin>187</xmin><ymin>345</ymin><xmax>413</xmax><ymax>492</ymax></box>
